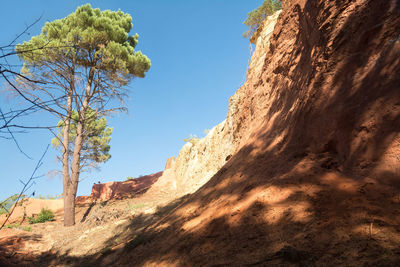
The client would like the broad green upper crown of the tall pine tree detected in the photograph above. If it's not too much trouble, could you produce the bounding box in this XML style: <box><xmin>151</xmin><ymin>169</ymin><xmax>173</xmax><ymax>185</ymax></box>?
<box><xmin>16</xmin><ymin>4</ymin><xmax>151</xmax><ymax>79</ymax></box>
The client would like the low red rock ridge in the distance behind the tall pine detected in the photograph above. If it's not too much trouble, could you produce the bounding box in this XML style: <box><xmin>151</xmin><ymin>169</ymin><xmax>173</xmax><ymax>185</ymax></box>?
<box><xmin>90</xmin><ymin>172</ymin><xmax>163</xmax><ymax>201</ymax></box>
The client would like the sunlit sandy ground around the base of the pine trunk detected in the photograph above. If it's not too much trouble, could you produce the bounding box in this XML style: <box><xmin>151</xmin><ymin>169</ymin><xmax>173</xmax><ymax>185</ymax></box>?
<box><xmin>0</xmin><ymin>187</ymin><xmax>181</xmax><ymax>266</ymax></box>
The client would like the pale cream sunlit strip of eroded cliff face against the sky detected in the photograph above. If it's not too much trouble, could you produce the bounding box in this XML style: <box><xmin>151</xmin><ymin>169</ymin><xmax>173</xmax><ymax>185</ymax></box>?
<box><xmin>175</xmin><ymin>11</ymin><xmax>280</xmax><ymax>195</ymax></box>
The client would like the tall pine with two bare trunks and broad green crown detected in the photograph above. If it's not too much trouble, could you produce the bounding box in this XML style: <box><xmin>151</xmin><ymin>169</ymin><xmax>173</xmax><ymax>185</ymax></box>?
<box><xmin>16</xmin><ymin>4</ymin><xmax>151</xmax><ymax>226</ymax></box>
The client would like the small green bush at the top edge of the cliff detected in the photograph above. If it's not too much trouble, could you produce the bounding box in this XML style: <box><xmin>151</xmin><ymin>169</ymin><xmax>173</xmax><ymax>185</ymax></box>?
<box><xmin>243</xmin><ymin>0</ymin><xmax>282</xmax><ymax>38</ymax></box>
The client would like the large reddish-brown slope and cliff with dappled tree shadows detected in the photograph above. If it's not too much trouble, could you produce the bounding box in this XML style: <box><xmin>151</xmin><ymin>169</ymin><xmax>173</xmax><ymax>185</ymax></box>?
<box><xmin>0</xmin><ymin>0</ymin><xmax>400</xmax><ymax>266</ymax></box>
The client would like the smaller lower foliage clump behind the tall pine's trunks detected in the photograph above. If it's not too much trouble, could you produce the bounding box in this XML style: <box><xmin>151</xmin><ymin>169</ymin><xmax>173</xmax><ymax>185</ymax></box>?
<box><xmin>51</xmin><ymin>108</ymin><xmax>113</xmax><ymax>171</ymax></box>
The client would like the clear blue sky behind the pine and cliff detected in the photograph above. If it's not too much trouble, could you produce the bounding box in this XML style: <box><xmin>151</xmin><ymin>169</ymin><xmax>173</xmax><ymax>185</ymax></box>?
<box><xmin>0</xmin><ymin>0</ymin><xmax>262</xmax><ymax>199</ymax></box>
